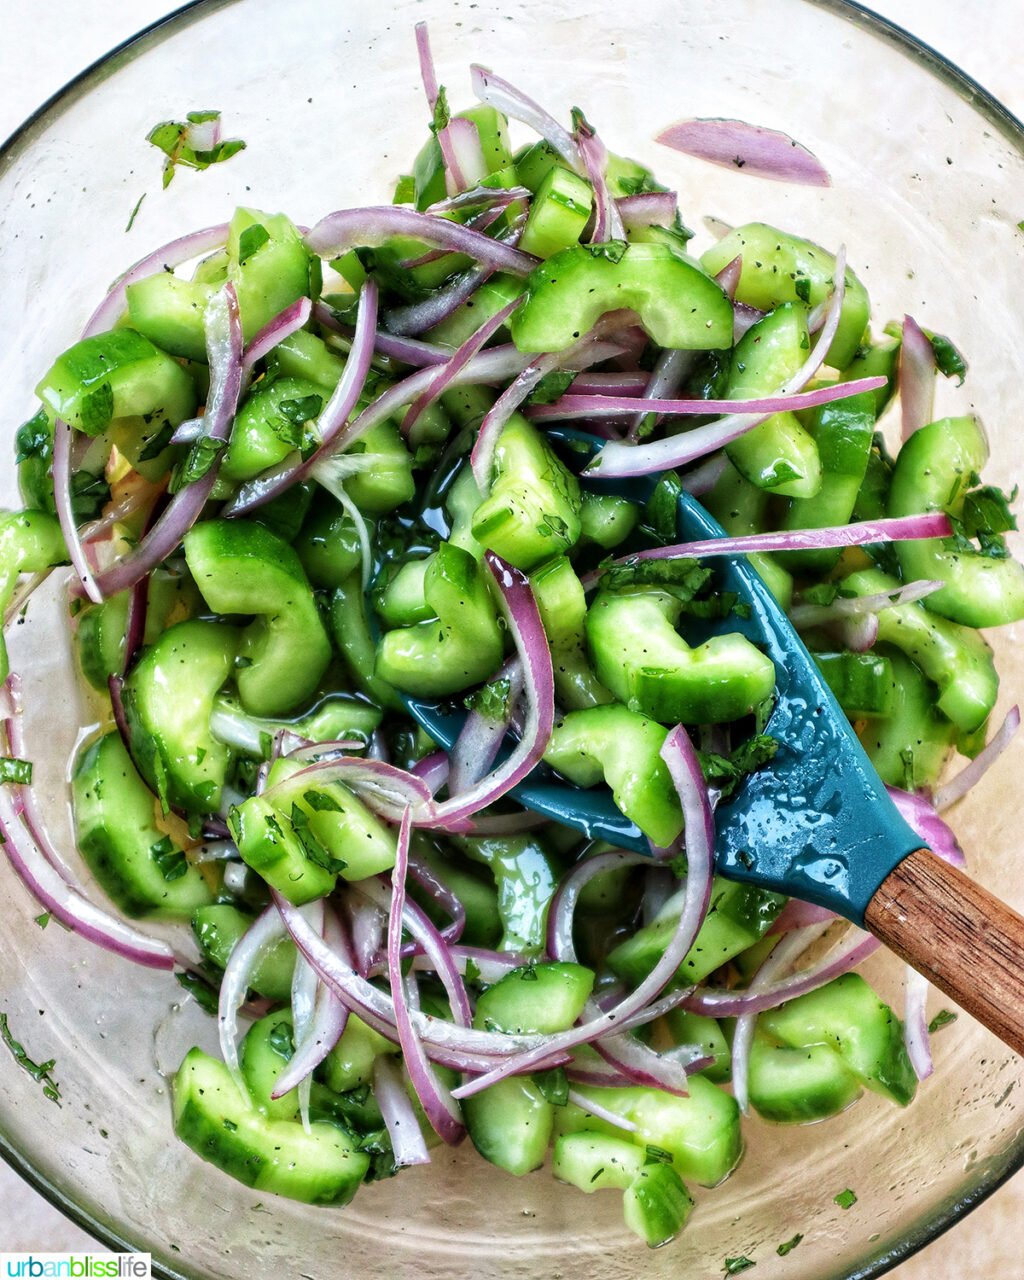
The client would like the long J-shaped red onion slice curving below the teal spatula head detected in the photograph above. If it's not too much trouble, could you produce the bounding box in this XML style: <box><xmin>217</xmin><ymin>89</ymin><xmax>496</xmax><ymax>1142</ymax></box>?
<box><xmin>454</xmin><ymin>726</ymin><xmax>714</xmax><ymax>1098</ymax></box>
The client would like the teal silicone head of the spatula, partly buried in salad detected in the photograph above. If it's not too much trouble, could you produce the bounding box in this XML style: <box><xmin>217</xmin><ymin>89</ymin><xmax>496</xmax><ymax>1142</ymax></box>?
<box><xmin>407</xmin><ymin>431</ymin><xmax>922</xmax><ymax>923</ymax></box>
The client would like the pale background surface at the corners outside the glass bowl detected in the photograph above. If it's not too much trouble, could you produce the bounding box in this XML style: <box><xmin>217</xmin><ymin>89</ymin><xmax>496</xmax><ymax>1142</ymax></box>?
<box><xmin>0</xmin><ymin>0</ymin><xmax>1024</xmax><ymax>1280</ymax></box>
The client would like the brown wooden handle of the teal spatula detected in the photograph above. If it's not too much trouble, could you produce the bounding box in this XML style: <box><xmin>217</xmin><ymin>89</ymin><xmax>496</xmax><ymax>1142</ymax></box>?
<box><xmin>864</xmin><ymin>849</ymin><xmax>1024</xmax><ymax>1053</ymax></box>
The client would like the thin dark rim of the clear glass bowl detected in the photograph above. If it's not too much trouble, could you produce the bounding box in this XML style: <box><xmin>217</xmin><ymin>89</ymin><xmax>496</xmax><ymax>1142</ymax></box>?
<box><xmin>0</xmin><ymin>0</ymin><xmax>1024</xmax><ymax>1280</ymax></box>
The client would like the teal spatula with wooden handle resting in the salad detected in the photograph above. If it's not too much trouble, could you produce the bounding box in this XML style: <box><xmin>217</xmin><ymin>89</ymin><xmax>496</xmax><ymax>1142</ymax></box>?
<box><xmin>396</xmin><ymin>431</ymin><xmax>1024</xmax><ymax>1053</ymax></box>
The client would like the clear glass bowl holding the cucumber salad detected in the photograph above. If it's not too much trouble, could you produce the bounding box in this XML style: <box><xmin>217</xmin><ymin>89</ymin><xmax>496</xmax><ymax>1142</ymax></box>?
<box><xmin>0</xmin><ymin>0</ymin><xmax>1024</xmax><ymax>1280</ymax></box>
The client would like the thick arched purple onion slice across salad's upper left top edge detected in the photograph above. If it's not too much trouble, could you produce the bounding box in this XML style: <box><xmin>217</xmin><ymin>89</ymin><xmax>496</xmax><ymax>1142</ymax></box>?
<box><xmin>306</xmin><ymin>205</ymin><xmax>538</xmax><ymax>275</ymax></box>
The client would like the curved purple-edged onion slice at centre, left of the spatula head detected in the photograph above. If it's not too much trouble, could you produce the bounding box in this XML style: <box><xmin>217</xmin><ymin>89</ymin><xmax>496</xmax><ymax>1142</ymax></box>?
<box><xmin>425</xmin><ymin>550</ymin><xmax>554</xmax><ymax>831</ymax></box>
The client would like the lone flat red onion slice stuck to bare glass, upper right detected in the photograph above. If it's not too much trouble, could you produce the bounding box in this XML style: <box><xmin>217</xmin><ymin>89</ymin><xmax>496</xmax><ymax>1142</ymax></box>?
<box><xmin>654</xmin><ymin>119</ymin><xmax>832</xmax><ymax>187</ymax></box>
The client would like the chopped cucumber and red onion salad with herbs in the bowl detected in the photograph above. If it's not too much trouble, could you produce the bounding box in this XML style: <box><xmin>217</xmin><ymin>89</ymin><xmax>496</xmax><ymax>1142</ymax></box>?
<box><xmin>0</xmin><ymin>27</ymin><xmax>1024</xmax><ymax>1245</ymax></box>
